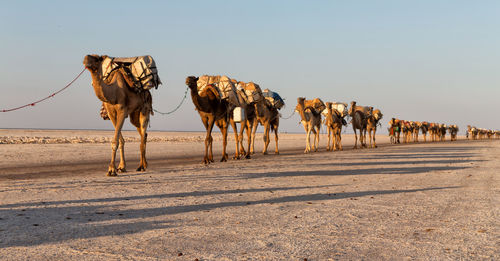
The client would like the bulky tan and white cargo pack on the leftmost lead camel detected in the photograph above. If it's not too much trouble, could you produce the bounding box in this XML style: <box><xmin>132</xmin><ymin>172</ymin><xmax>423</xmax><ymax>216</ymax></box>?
<box><xmin>101</xmin><ymin>55</ymin><xmax>161</xmax><ymax>91</ymax></box>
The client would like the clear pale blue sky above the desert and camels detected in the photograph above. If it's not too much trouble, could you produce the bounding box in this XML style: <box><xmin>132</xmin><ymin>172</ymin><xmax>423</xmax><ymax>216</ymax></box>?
<box><xmin>0</xmin><ymin>0</ymin><xmax>500</xmax><ymax>133</ymax></box>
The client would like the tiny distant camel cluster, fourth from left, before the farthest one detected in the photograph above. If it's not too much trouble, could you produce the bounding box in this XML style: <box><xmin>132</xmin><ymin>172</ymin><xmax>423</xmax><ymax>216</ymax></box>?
<box><xmin>388</xmin><ymin>118</ymin><xmax>459</xmax><ymax>144</ymax></box>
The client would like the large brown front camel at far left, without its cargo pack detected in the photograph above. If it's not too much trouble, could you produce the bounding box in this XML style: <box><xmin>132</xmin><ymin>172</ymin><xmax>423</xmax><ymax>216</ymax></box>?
<box><xmin>83</xmin><ymin>55</ymin><xmax>153</xmax><ymax>176</ymax></box>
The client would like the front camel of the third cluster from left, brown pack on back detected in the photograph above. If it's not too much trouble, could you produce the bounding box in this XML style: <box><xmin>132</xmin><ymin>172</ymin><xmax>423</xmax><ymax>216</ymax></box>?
<box><xmin>295</xmin><ymin>97</ymin><xmax>326</xmax><ymax>153</ymax></box>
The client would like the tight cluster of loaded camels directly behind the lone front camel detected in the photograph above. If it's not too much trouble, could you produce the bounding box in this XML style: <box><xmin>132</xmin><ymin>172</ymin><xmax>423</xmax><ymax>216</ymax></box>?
<box><xmin>186</xmin><ymin>75</ymin><xmax>285</xmax><ymax>164</ymax></box>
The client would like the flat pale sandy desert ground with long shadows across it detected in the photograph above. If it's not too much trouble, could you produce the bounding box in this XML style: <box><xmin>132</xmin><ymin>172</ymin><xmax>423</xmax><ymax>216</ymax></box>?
<box><xmin>0</xmin><ymin>130</ymin><xmax>500</xmax><ymax>260</ymax></box>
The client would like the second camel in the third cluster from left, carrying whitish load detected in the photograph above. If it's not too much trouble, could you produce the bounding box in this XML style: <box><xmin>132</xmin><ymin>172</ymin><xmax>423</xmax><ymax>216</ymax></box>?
<box><xmin>323</xmin><ymin>102</ymin><xmax>345</xmax><ymax>151</ymax></box>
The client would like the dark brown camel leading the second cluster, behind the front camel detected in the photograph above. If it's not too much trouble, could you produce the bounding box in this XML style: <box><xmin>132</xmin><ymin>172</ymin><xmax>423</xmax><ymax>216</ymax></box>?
<box><xmin>186</xmin><ymin>76</ymin><xmax>240</xmax><ymax>164</ymax></box>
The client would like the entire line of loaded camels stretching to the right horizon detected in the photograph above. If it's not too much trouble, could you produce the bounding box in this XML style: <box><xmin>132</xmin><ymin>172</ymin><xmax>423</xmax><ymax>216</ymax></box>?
<box><xmin>83</xmin><ymin>55</ymin><xmax>500</xmax><ymax>176</ymax></box>
